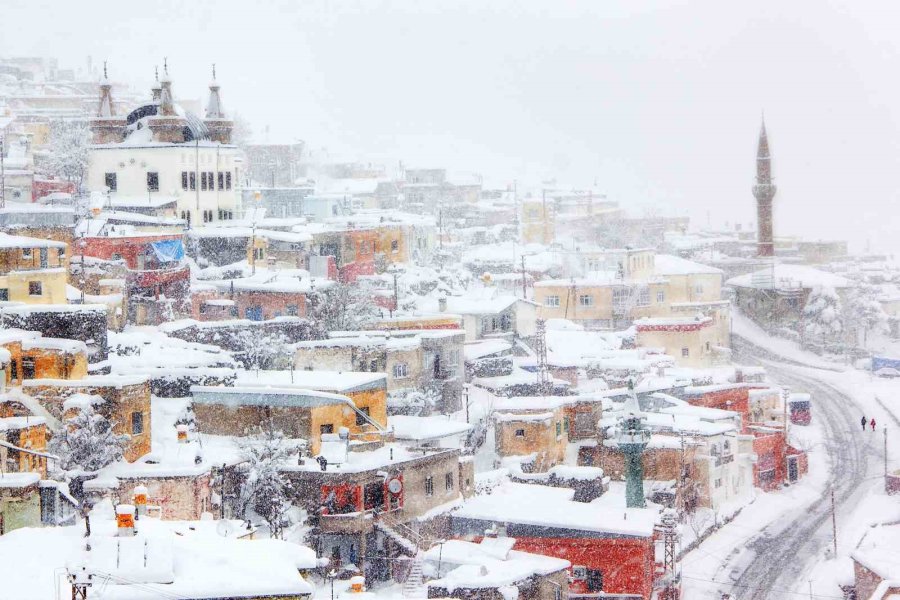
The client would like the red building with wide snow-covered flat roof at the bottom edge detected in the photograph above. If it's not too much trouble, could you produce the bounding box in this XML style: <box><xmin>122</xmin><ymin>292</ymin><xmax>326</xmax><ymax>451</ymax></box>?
<box><xmin>451</xmin><ymin>482</ymin><xmax>657</xmax><ymax>600</ymax></box>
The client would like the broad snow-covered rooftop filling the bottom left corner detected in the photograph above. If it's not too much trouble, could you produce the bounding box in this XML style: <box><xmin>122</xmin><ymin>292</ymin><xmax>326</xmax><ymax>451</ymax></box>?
<box><xmin>0</xmin><ymin>502</ymin><xmax>317</xmax><ymax>600</ymax></box>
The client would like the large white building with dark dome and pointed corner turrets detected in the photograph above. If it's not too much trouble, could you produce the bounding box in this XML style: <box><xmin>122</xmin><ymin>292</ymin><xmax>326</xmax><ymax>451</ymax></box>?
<box><xmin>87</xmin><ymin>64</ymin><xmax>242</xmax><ymax>224</ymax></box>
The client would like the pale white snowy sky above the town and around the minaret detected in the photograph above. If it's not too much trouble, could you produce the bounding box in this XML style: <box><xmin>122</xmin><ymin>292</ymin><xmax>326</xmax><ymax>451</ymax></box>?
<box><xmin>0</xmin><ymin>0</ymin><xmax>900</xmax><ymax>253</ymax></box>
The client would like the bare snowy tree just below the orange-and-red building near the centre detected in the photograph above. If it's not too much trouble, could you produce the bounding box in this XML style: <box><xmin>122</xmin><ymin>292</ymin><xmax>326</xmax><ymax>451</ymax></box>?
<box><xmin>308</xmin><ymin>281</ymin><xmax>381</xmax><ymax>331</ymax></box>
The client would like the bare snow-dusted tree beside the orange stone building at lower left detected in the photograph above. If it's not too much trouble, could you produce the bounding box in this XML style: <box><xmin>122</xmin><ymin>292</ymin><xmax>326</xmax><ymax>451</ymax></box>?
<box><xmin>49</xmin><ymin>403</ymin><xmax>128</xmax><ymax>475</ymax></box>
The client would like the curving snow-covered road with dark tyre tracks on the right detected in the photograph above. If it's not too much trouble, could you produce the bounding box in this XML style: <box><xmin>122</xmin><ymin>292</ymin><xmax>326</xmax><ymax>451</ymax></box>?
<box><xmin>731</xmin><ymin>336</ymin><xmax>881</xmax><ymax>600</ymax></box>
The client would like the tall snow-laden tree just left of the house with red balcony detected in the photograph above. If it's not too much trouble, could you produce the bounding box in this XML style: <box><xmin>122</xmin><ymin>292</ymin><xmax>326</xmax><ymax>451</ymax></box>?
<box><xmin>239</xmin><ymin>423</ymin><xmax>297</xmax><ymax>538</ymax></box>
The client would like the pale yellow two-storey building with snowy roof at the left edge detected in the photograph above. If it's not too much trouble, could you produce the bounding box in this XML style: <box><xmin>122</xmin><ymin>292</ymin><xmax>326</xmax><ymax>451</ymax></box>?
<box><xmin>0</xmin><ymin>233</ymin><xmax>67</xmax><ymax>304</ymax></box>
